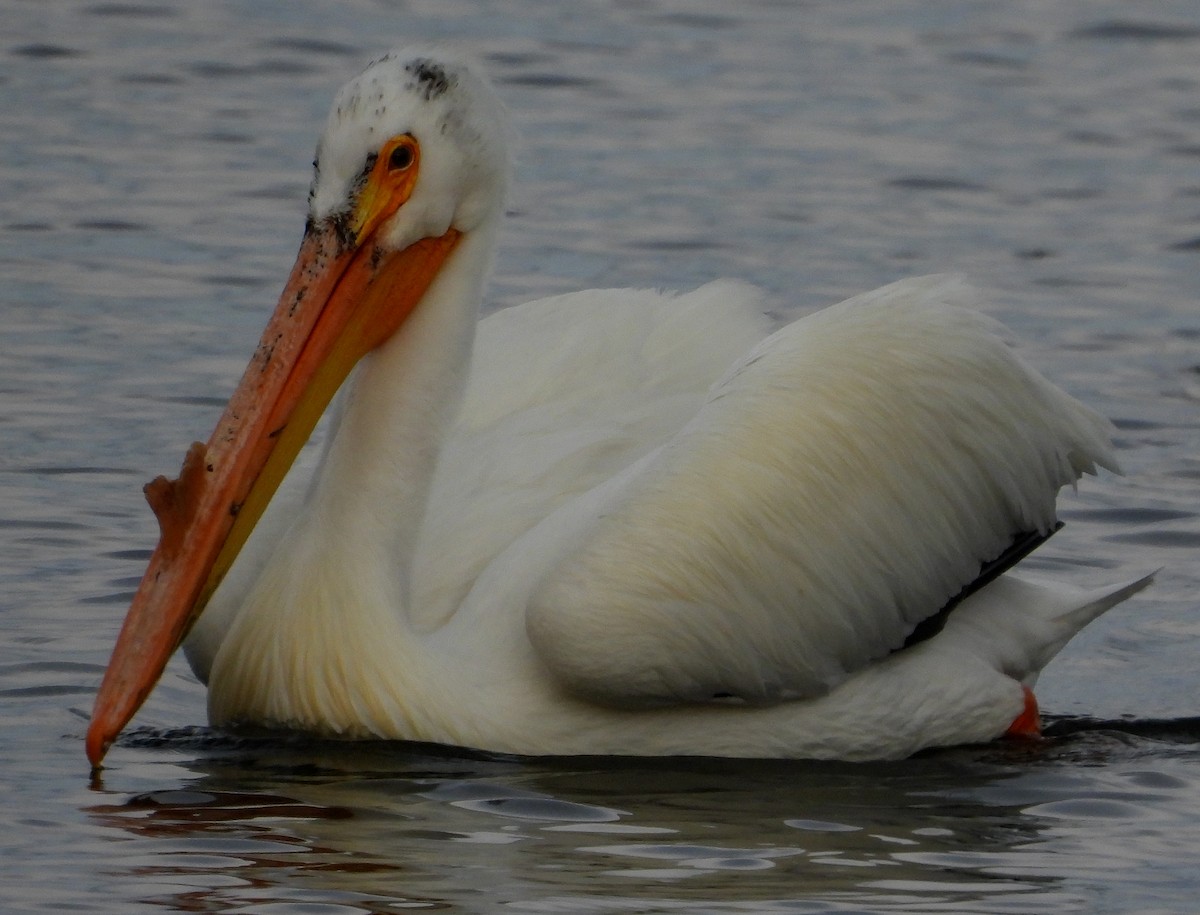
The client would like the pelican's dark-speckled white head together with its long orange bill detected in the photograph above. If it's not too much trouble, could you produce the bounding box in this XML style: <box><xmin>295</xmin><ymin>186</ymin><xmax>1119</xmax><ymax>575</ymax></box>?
<box><xmin>88</xmin><ymin>49</ymin><xmax>509</xmax><ymax>765</ymax></box>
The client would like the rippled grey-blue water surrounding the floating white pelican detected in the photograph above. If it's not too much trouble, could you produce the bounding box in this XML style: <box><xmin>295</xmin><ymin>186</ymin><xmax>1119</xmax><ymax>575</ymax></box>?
<box><xmin>0</xmin><ymin>0</ymin><xmax>1200</xmax><ymax>915</ymax></box>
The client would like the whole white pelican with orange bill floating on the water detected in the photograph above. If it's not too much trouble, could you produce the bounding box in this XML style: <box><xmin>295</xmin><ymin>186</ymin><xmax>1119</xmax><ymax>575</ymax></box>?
<box><xmin>88</xmin><ymin>50</ymin><xmax>1146</xmax><ymax>765</ymax></box>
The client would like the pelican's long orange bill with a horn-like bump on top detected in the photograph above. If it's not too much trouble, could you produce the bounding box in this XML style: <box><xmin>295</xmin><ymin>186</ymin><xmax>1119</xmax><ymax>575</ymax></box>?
<box><xmin>86</xmin><ymin>137</ymin><xmax>460</xmax><ymax>767</ymax></box>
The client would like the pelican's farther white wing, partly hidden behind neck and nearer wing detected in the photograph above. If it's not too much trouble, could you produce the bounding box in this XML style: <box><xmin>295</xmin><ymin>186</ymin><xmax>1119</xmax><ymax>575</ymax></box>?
<box><xmin>413</xmin><ymin>281</ymin><xmax>769</xmax><ymax>628</ymax></box>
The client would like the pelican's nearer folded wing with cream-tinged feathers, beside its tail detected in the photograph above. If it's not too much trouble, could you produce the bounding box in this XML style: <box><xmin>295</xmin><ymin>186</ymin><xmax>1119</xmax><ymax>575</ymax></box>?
<box><xmin>526</xmin><ymin>277</ymin><xmax>1115</xmax><ymax>705</ymax></box>
